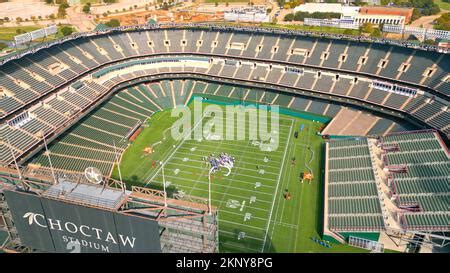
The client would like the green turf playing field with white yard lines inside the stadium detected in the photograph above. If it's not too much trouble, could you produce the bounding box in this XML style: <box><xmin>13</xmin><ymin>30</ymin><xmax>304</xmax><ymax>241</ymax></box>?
<box><xmin>113</xmin><ymin>98</ymin><xmax>364</xmax><ymax>252</ymax></box>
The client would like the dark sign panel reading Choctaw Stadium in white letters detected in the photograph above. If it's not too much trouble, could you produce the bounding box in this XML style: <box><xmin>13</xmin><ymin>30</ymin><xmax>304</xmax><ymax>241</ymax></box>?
<box><xmin>5</xmin><ymin>188</ymin><xmax>161</xmax><ymax>253</ymax></box>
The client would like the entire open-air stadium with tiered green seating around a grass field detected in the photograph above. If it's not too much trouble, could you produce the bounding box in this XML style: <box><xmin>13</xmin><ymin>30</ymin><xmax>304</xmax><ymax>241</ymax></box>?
<box><xmin>0</xmin><ymin>24</ymin><xmax>450</xmax><ymax>253</ymax></box>
